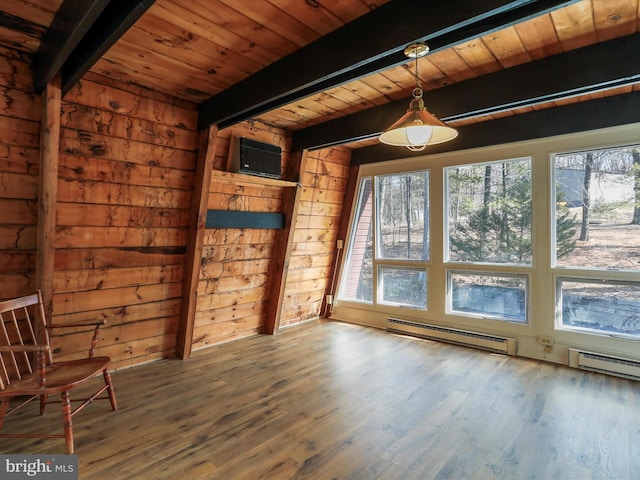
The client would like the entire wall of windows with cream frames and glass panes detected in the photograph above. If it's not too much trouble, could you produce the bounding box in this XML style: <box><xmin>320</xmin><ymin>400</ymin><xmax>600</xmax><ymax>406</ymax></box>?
<box><xmin>333</xmin><ymin>124</ymin><xmax>640</xmax><ymax>362</ymax></box>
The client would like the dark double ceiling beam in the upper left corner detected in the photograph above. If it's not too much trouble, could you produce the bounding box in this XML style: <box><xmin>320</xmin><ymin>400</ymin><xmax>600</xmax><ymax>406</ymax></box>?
<box><xmin>34</xmin><ymin>0</ymin><xmax>155</xmax><ymax>95</ymax></box>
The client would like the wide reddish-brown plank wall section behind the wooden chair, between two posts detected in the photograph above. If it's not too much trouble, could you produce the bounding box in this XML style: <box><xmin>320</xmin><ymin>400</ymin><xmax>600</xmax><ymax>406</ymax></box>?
<box><xmin>52</xmin><ymin>76</ymin><xmax>198</xmax><ymax>368</ymax></box>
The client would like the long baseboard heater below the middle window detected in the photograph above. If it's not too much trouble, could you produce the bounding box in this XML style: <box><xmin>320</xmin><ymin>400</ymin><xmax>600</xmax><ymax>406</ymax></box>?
<box><xmin>387</xmin><ymin>317</ymin><xmax>516</xmax><ymax>356</ymax></box>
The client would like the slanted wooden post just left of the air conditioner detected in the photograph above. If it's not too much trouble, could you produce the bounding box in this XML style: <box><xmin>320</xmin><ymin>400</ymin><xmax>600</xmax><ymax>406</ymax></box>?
<box><xmin>176</xmin><ymin>126</ymin><xmax>218</xmax><ymax>359</ymax></box>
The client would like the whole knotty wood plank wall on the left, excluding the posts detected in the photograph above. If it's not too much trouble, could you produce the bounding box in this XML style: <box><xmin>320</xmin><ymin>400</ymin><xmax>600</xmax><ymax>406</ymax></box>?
<box><xmin>0</xmin><ymin>40</ymin><xmax>349</xmax><ymax>368</ymax></box>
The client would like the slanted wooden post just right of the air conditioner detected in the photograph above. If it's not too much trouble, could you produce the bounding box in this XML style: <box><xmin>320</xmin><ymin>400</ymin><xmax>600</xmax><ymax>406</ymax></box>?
<box><xmin>265</xmin><ymin>150</ymin><xmax>307</xmax><ymax>335</ymax></box>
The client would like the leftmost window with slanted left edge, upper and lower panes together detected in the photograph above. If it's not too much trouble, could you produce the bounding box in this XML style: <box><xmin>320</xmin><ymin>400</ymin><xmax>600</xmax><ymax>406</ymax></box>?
<box><xmin>338</xmin><ymin>171</ymin><xmax>430</xmax><ymax>310</ymax></box>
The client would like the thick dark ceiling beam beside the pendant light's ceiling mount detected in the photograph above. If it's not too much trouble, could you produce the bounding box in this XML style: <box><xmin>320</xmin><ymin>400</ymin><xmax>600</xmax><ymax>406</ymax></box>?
<box><xmin>198</xmin><ymin>0</ymin><xmax>577</xmax><ymax>129</ymax></box>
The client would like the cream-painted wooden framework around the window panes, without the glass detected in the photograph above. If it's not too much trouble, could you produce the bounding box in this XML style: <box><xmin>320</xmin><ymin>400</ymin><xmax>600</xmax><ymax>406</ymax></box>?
<box><xmin>331</xmin><ymin>122</ymin><xmax>640</xmax><ymax>364</ymax></box>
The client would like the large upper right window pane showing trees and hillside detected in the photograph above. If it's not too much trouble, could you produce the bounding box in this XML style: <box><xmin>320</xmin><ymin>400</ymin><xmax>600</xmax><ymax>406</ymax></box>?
<box><xmin>553</xmin><ymin>145</ymin><xmax>640</xmax><ymax>271</ymax></box>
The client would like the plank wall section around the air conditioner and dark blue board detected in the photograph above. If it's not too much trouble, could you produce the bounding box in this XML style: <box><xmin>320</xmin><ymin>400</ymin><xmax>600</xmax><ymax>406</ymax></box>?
<box><xmin>193</xmin><ymin>122</ymin><xmax>291</xmax><ymax>350</ymax></box>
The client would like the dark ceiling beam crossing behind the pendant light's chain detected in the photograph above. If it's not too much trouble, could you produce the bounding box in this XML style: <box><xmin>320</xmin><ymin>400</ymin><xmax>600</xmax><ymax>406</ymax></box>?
<box><xmin>292</xmin><ymin>33</ymin><xmax>640</xmax><ymax>151</ymax></box>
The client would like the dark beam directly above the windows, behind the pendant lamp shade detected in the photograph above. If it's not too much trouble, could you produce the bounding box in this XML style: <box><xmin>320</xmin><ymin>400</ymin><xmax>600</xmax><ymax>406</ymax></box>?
<box><xmin>351</xmin><ymin>92</ymin><xmax>640</xmax><ymax>165</ymax></box>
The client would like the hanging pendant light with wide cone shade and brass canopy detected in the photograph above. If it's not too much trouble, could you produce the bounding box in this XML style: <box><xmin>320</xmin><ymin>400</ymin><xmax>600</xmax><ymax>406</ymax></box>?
<box><xmin>380</xmin><ymin>43</ymin><xmax>458</xmax><ymax>152</ymax></box>
